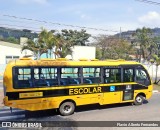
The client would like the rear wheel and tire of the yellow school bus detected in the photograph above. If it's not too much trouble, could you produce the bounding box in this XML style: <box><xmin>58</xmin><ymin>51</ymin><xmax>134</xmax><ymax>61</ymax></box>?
<box><xmin>59</xmin><ymin>102</ymin><xmax>75</xmax><ymax>116</ymax></box>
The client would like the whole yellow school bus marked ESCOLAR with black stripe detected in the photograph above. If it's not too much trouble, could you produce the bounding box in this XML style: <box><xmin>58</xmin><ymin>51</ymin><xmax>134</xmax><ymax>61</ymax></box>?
<box><xmin>3</xmin><ymin>58</ymin><xmax>152</xmax><ymax>116</ymax></box>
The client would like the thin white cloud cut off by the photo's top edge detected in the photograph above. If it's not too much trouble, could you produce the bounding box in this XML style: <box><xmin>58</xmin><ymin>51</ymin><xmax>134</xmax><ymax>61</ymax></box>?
<box><xmin>15</xmin><ymin>0</ymin><xmax>48</xmax><ymax>4</ymax></box>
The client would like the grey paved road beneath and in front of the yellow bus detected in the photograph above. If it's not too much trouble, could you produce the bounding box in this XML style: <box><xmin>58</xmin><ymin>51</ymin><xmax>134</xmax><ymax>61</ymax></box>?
<box><xmin>0</xmin><ymin>93</ymin><xmax>160</xmax><ymax>130</ymax></box>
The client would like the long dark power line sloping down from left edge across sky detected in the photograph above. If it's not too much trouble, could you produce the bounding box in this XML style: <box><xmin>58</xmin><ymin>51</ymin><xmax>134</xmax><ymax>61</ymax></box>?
<box><xmin>2</xmin><ymin>14</ymin><xmax>119</xmax><ymax>32</ymax></box>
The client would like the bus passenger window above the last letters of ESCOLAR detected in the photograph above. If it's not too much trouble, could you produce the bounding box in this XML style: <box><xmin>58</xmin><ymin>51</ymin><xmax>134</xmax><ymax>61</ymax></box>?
<box><xmin>83</xmin><ymin>67</ymin><xmax>100</xmax><ymax>84</ymax></box>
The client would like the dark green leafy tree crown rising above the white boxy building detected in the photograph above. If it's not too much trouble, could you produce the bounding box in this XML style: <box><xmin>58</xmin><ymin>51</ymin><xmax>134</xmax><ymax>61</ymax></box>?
<box><xmin>62</xmin><ymin>29</ymin><xmax>91</xmax><ymax>46</ymax></box>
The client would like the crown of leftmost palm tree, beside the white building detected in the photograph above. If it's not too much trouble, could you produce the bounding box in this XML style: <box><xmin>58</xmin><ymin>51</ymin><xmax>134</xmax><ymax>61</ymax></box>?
<box><xmin>22</xmin><ymin>39</ymin><xmax>47</xmax><ymax>59</ymax></box>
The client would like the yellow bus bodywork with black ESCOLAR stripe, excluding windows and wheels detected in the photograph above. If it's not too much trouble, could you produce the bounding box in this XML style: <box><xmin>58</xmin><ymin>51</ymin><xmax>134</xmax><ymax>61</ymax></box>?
<box><xmin>4</xmin><ymin>60</ymin><xmax>153</xmax><ymax>111</ymax></box>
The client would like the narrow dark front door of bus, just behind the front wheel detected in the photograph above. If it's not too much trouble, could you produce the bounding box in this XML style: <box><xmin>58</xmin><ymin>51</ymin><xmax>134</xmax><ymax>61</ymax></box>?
<box><xmin>121</xmin><ymin>66</ymin><xmax>135</xmax><ymax>102</ymax></box>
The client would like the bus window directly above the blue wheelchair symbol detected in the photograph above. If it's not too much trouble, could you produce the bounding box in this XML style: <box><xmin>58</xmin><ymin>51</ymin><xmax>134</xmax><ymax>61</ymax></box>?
<box><xmin>104</xmin><ymin>68</ymin><xmax>121</xmax><ymax>83</ymax></box>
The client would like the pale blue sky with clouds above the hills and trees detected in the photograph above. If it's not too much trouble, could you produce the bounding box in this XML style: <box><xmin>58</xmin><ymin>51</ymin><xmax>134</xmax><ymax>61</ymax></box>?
<box><xmin>0</xmin><ymin>0</ymin><xmax>160</xmax><ymax>35</ymax></box>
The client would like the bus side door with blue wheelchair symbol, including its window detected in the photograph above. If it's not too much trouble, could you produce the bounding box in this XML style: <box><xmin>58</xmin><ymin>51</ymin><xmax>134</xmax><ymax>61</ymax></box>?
<box><xmin>103</xmin><ymin>67</ymin><xmax>122</xmax><ymax>104</ymax></box>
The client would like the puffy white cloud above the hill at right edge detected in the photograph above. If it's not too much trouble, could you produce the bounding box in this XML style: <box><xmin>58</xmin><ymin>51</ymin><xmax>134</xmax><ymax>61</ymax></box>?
<box><xmin>138</xmin><ymin>11</ymin><xmax>160</xmax><ymax>27</ymax></box>
